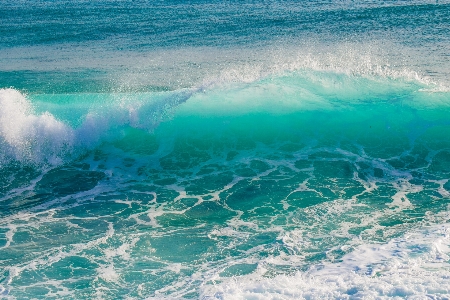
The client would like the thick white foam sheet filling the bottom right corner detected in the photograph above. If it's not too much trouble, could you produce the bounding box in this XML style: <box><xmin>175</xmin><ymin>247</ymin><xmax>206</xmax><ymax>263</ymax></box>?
<box><xmin>202</xmin><ymin>223</ymin><xmax>450</xmax><ymax>299</ymax></box>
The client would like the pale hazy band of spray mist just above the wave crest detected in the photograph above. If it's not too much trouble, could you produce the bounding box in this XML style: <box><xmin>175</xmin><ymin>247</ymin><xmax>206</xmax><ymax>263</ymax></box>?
<box><xmin>0</xmin><ymin>37</ymin><xmax>450</xmax><ymax>93</ymax></box>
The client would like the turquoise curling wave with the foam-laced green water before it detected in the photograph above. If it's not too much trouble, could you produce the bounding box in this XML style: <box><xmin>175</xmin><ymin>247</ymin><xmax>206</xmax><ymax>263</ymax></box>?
<box><xmin>0</xmin><ymin>73</ymin><xmax>450</xmax><ymax>298</ymax></box>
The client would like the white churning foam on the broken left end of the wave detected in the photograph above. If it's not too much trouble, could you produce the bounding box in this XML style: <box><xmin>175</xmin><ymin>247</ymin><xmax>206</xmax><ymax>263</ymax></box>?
<box><xmin>0</xmin><ymin>89</ymin><xmax>198</xmax><ymax>166</ymax></box>
